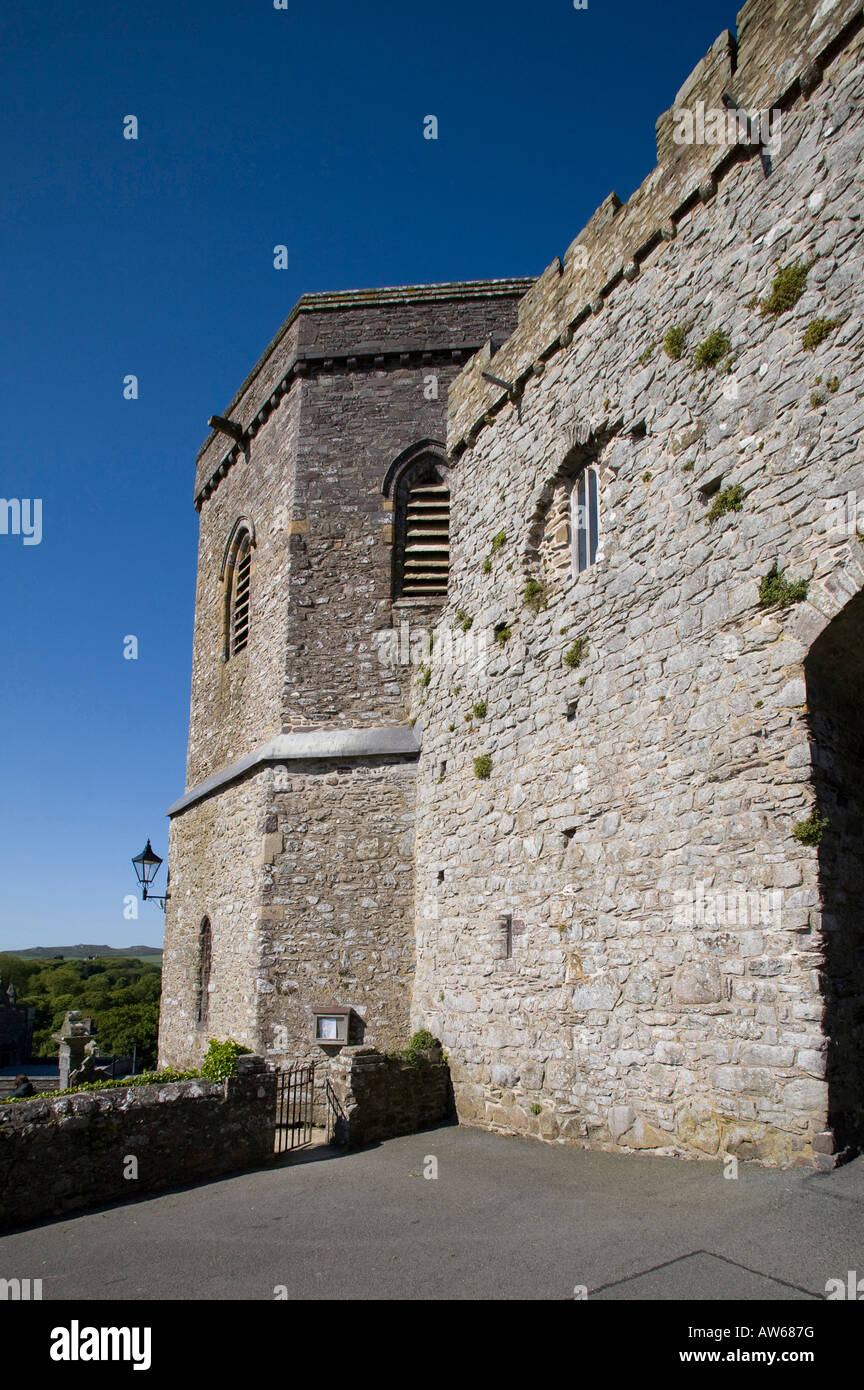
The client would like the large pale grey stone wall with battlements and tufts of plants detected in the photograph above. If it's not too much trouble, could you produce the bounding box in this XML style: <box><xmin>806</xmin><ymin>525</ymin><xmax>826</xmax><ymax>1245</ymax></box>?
<box><xmin>413</xmin><ymin>0</ymin><xmax>864</xmax><ymax>1166</ymax></box>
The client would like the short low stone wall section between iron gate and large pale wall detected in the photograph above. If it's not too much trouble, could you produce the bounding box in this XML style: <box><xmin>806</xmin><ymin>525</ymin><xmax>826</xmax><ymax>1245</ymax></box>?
<box><xmin>326</xmin><ymin>1047</ymin><xmax>456</xmax><ymax>1148</ymax></box>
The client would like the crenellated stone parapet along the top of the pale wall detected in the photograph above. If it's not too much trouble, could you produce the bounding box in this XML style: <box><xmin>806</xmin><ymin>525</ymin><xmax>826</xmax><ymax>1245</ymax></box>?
<box><xmin>447</xmin><ymin>0</ymin><xmax>864</xmax><ymax>457</ymax></box>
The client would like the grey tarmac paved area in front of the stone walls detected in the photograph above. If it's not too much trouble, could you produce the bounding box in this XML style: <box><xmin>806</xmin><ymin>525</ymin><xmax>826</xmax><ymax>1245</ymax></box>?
<box><xmin>0</xmin><ymin>1127</ymin><xmax>864</xmax><ymax>1300</ymax></box>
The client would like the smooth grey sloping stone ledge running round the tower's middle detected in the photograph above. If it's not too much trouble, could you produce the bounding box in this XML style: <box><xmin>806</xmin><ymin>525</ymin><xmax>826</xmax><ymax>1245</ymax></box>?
<box><xmin>167</xmin><ymin>724</ymin><xmax>421</xmax><ymax>816</ymax></box>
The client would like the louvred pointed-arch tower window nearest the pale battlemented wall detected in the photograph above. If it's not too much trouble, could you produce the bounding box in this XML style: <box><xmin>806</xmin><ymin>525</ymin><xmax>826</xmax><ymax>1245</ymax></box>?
<box><xmin>393</xmin><ymin>448</ymin><xmax>450</xmax><ymax>600</ymax></box>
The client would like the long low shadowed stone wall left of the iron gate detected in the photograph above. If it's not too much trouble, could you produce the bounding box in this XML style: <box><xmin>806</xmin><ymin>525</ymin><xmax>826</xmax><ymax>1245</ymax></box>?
<box><xmin>0</xmin><ymin>1056</ymin><xmax>276</xmax><ymax>1229</ymax></box>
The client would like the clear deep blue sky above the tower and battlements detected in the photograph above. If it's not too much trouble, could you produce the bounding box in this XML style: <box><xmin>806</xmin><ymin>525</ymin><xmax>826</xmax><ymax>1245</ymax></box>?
<box><xmin>0</xmin><ymin>0</ymin><xmax>735</xmax><ymax>949</ymax></box>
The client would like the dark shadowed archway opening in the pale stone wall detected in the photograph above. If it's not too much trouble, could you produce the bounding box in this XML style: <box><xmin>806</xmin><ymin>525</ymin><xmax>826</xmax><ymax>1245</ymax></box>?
<box><xmin>806</xmin><ymin>594</ymin><xmax>864</xmax><ymax>1156</ymax></box>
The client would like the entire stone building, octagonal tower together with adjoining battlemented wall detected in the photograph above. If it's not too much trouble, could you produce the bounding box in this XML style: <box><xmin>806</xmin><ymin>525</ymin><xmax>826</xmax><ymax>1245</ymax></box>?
<box><xmin>163</xmin><ymin>0</ymin><xmax>864</xmax><ymax>1168</ymax></box>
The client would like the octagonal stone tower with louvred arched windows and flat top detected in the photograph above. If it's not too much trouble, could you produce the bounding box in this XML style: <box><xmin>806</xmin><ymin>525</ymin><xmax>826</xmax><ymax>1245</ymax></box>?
<box><xmin>160</xmin><ymin>279</ymin><xmax>531</xmax><ymax>1065</ymax></box>
